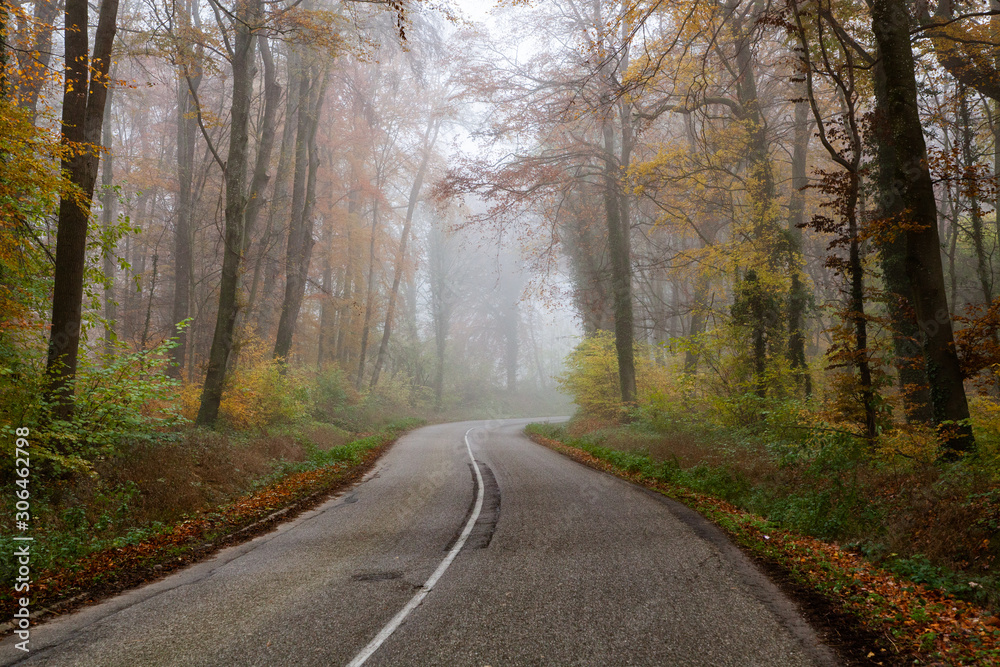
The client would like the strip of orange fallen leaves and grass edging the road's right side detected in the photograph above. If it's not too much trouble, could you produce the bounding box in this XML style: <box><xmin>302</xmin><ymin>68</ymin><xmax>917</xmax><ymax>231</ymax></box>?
<box><xmin>528</xmin><ymin>425</ymin><xmax>1000</xmax><ymax>665</ymax></box>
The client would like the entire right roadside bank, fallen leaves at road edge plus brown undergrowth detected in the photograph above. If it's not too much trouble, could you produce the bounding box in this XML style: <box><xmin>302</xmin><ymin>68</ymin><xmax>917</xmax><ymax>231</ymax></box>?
<box><xmin>527</xmin><ymin>420</ymin><xmax>1000</xmax><ymax>665</ymax></box>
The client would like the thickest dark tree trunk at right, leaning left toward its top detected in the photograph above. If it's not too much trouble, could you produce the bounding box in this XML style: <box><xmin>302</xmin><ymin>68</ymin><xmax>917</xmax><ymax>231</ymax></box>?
<box><xmin>871</xmin><ymin>0</ymin><xmax>975</xmax><ymax>455</ymax></box>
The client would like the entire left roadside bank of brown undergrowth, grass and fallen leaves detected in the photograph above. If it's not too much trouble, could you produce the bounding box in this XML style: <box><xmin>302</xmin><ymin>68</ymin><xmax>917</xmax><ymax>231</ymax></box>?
<box><xmin>0</xmin><ymin>418</ymin><xmax>422</xmax><ymax>616</ymax></box>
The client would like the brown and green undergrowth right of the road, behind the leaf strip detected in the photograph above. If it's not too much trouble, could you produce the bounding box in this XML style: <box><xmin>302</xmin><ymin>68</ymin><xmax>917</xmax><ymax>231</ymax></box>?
<box><xmin>529</xmin><ymin>419</ymin><xmax>1000</xmax><ymax>609</ymax></box>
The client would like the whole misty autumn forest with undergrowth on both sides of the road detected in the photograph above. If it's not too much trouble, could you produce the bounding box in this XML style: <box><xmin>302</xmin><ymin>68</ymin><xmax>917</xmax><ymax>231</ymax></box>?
<box><xmin>7</xmin><ymin>0</ymin><xmax>1000</xmax><ymax>620</ymax></box>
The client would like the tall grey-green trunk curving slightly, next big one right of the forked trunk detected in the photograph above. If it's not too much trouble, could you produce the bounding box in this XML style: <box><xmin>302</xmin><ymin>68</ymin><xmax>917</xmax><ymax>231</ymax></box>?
<box><xmin>197</xmin><ymin>0</ymin><xmax>261</xmax><ymax>425</ymax></box>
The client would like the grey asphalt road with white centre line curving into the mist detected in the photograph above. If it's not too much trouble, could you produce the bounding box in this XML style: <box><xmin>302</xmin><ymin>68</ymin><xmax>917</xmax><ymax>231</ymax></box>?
<box><xmin>0</xmin><ymin>420</ymin><xmax>836</xmax><ymax>667</ymax></box>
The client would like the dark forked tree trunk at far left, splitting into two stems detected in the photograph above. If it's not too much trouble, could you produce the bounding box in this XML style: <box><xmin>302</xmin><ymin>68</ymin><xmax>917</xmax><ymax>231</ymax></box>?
<box><xmin>46</xmin><ymin>0</ymin><xmax>118</xmax><ymax>419</ymax></box>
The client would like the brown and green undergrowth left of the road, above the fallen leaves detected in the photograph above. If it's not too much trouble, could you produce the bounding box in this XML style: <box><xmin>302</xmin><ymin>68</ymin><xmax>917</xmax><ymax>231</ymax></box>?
<box><xmin>0</xmin><ymin>419</ymin><xmax>421</xmax><ymax>596</ymax></box>
